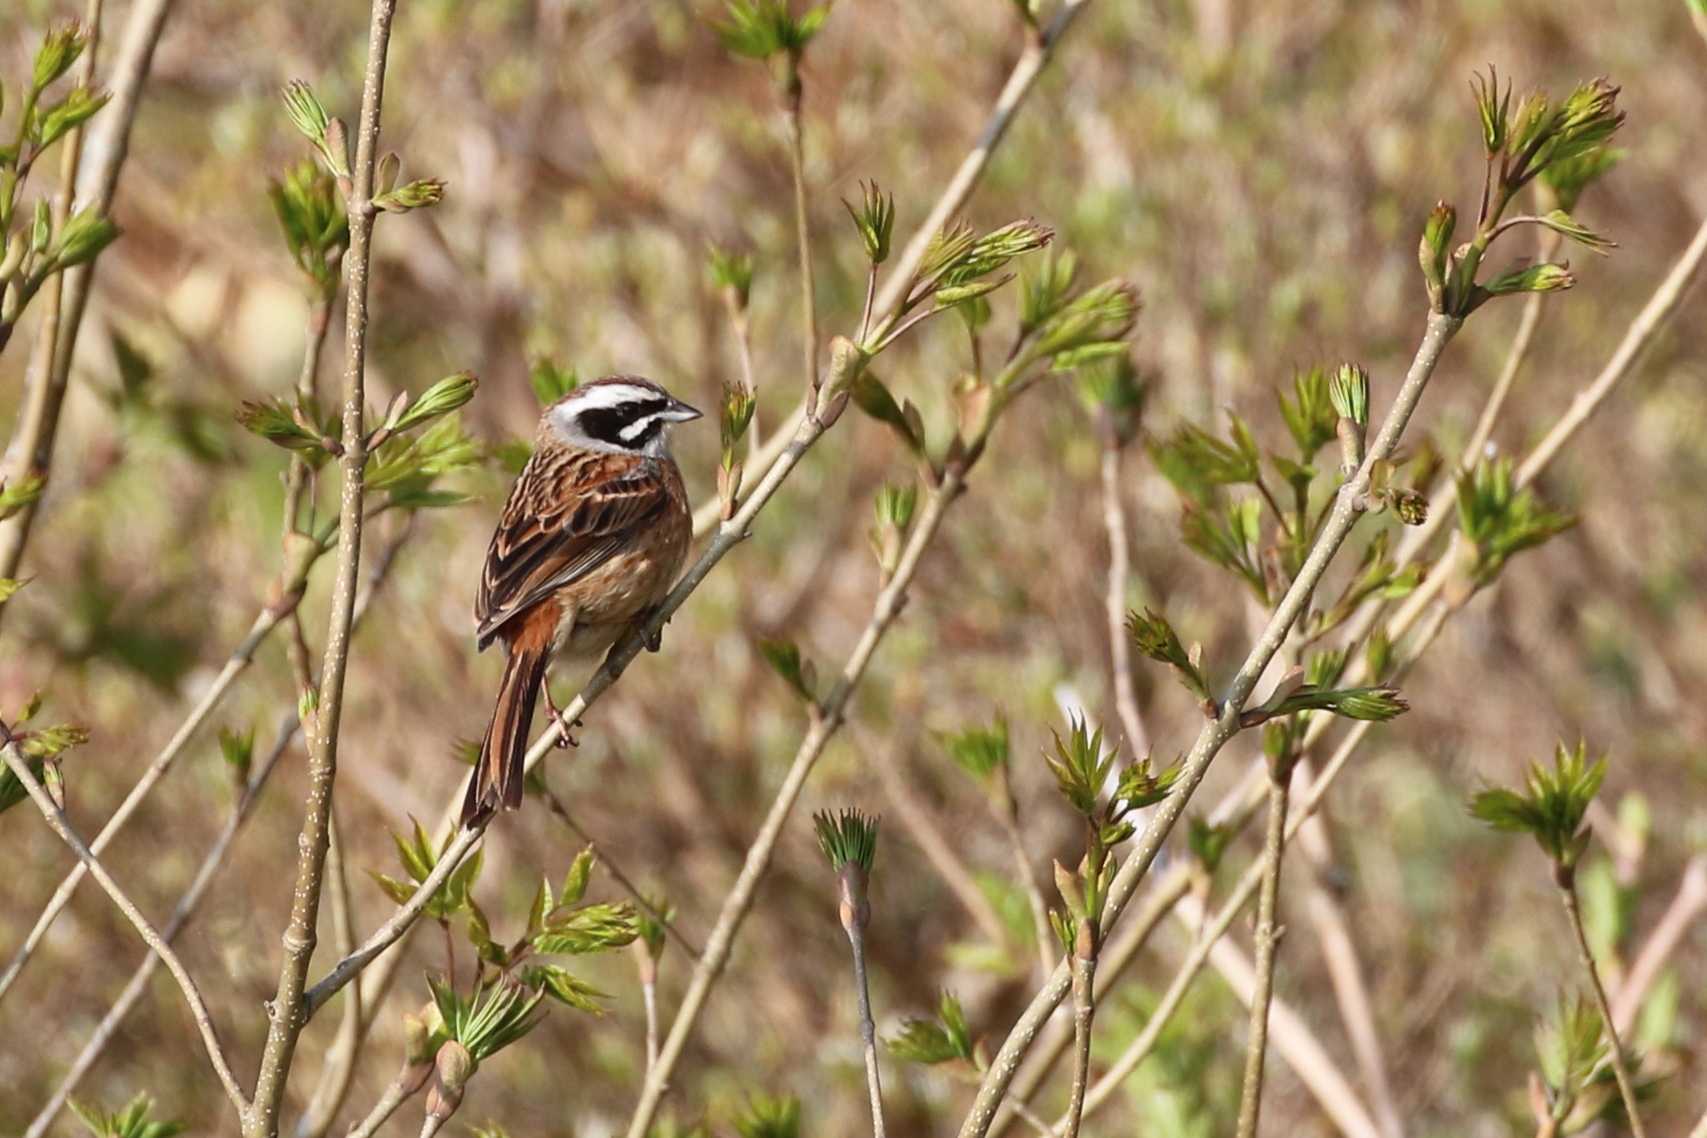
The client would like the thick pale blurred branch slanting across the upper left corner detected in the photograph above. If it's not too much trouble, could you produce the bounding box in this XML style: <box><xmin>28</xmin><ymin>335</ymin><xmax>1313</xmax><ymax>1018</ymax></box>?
<box><xmin>0</xmin><ymin>0</ymin><xmax>172</xmax><ymax>577</ymax></box>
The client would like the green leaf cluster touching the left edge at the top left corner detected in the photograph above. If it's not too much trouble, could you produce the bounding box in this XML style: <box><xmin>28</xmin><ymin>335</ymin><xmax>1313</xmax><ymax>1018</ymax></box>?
<box><xmin>0</xmin><ymin>24</ymin><xmax>118</xmax><ymax>350</ymax></box>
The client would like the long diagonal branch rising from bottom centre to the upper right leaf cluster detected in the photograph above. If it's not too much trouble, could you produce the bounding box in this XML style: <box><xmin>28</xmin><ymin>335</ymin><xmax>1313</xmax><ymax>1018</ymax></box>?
<box><xmin>959</xmin><ymin>312</ymin><xmax>1461</xmax><ymax>1138</ymax></box>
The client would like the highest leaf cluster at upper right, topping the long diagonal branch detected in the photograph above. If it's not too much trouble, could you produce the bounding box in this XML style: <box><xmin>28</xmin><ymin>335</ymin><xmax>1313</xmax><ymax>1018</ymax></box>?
<box><xmin>1419</xmin><ymin>68</ymin><xmax>1623</xmax><ymax>316</ymax></box>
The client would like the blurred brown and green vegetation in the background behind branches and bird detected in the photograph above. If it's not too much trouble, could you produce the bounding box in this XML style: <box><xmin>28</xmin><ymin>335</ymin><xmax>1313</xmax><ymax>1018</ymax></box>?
<box><xmin>0</xmin><ymin>0</ymin><xmax>1707</xmax><ymax>1138</ymax></box>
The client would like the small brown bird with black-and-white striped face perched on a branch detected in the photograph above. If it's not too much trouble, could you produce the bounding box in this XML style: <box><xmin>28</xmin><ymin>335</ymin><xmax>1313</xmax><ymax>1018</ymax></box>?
<box><xmin>463</xmin><ymin>375</ymin><xmax>700</xmax><ymax>826</ymax></box>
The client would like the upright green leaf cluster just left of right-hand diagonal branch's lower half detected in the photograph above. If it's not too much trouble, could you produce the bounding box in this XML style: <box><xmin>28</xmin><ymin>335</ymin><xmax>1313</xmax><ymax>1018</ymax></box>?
<box><xmin>1043</xmin><ymin>717</ymin><xmax>1181</xmax><ymax>955</ymax></box>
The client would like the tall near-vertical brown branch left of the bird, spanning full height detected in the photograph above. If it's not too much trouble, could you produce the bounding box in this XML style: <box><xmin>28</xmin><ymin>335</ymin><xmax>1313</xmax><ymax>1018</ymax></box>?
<box><xmin>242</xmin><ymin>0</ymin><xmax>396</xmax><ymax>1138</ymax></box>
